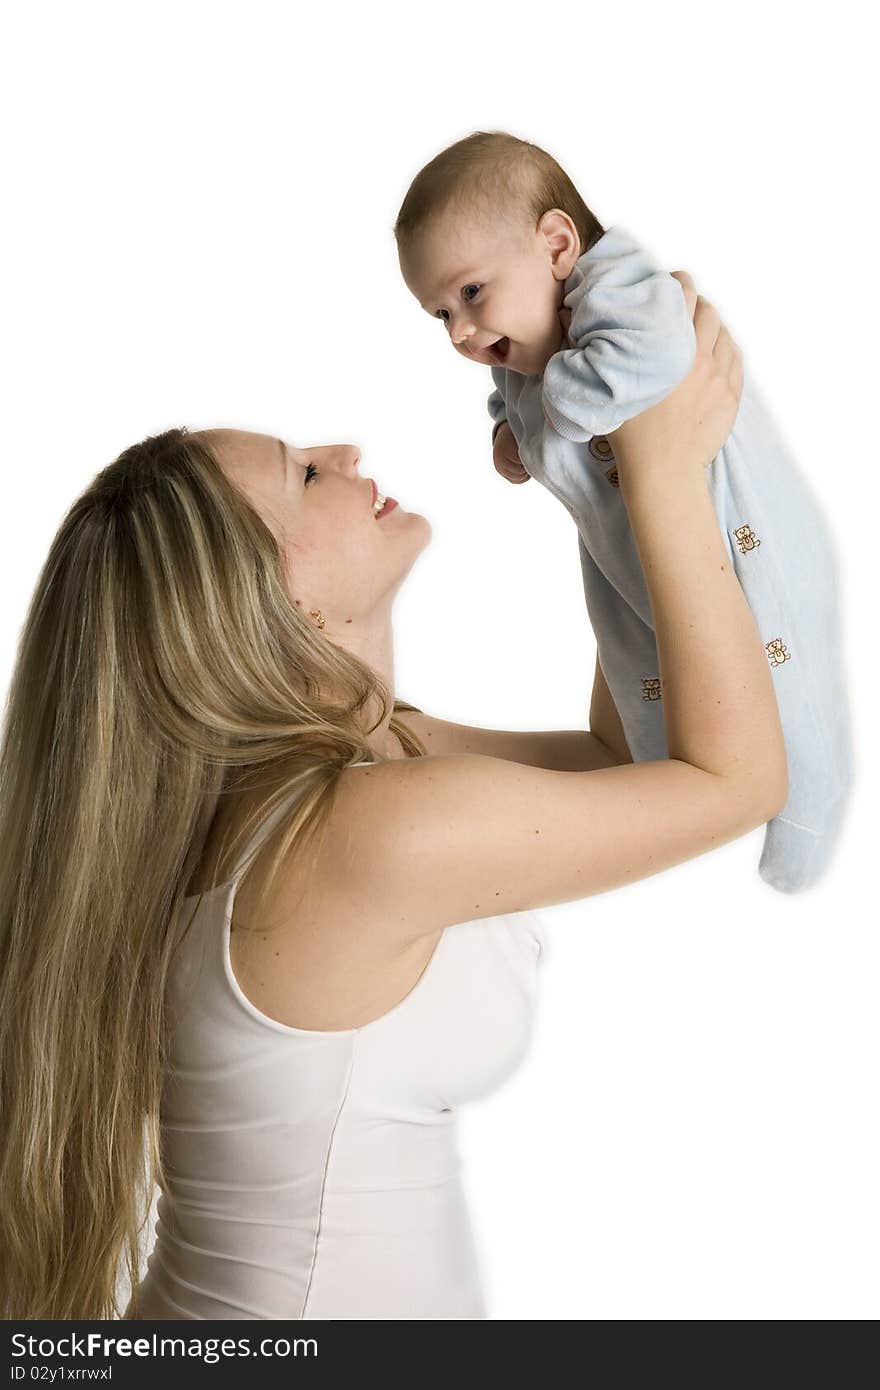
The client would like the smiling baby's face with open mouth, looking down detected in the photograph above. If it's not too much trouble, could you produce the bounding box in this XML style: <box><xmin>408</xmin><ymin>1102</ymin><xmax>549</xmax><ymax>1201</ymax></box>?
<box><xmin>400</xmin><ymin>205</ymin><xmax>578</xmax><ymax>377</ymax></box>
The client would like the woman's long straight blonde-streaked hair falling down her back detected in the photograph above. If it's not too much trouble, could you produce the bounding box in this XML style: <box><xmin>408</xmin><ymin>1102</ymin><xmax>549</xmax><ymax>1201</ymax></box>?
<box><xmin>0</xmin><ymin>428</ymin><xmax>425</xmax><ymax>1321</ymax></box>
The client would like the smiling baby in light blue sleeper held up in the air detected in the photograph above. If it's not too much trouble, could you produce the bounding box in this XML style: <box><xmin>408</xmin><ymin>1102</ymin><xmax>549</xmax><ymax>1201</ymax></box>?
<box><xmin>395</xmin><ymin>132</ymin><xmax>852</xmax><ymax>892</ymax></box>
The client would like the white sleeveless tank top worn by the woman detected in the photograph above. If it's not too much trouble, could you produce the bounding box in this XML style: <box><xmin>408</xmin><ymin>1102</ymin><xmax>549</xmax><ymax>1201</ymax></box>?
<box><xmin>130</xmin><ymin>765</ymin><xmax>546</xmax><ymax>1319</ymax></box>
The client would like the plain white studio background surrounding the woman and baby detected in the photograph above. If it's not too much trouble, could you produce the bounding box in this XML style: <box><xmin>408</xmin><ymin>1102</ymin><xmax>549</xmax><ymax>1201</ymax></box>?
<box><xmin>0</xmin><ymin>0</ymin><xmax>880</xmax><ymax>1319</ymax></box>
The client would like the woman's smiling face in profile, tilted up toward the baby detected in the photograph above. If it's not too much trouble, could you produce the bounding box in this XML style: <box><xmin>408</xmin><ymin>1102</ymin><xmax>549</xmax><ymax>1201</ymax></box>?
<box><xmin>200</xmin><ymin>430</ymin><xmax>431</xmax><ymax>634</ymax></box>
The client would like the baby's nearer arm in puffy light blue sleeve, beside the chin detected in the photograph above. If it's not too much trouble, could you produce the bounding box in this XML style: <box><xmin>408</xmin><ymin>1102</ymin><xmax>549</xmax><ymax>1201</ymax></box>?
<box><xmin>541</xmin><ymin>227</ymin><xmax>696</xmax><ymax>443</ymax></box>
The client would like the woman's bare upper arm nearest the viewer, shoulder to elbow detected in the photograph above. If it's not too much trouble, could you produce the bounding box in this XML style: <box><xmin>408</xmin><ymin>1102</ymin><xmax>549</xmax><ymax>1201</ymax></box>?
<box><xmin>320</xmin><ymin>755</ymin><xmax>787</xmax><ymax>948</ymax></box>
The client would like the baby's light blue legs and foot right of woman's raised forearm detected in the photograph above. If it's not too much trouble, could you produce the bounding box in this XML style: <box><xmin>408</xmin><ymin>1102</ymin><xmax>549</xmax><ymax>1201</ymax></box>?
<box><xmin>709</xmin><ymin>382</ymin><xmax>854</xmax><ymax>892</ymax></box>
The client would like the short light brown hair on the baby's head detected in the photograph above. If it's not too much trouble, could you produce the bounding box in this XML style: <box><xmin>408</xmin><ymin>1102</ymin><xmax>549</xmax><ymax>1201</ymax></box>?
<box><xmin>393</xmin><ymin>131</ymin><xmax>605</xmax><ymax>256</ymax></box>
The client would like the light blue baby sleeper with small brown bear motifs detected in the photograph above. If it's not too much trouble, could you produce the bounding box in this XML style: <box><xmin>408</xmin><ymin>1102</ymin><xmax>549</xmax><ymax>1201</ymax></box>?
<box><xmin>488</xmin><ymin>227</ymin><xmax>854</xmax><ymax>892</ymax></box>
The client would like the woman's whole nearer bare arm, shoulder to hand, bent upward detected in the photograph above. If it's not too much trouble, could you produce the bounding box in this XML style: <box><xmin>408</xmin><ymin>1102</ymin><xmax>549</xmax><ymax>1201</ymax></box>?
<box><xmin>283</xmin><ymin>282</ymin><xmax>788</xmax><ymax>947</ymax></box>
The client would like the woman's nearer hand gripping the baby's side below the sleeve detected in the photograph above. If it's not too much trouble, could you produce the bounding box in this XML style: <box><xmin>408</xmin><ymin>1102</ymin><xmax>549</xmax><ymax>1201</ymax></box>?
<box><xmin>608</xmin><ymin>270</ymin><xmax>742</xmax><ymax>478</ymax></box>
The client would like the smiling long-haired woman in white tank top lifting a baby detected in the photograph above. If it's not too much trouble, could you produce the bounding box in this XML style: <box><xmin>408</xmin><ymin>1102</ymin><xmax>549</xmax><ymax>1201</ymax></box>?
<box><xmin>0</xmin><ymin>274</ymin><xmax>787</xmax><ymax>1319</ymax></box>
